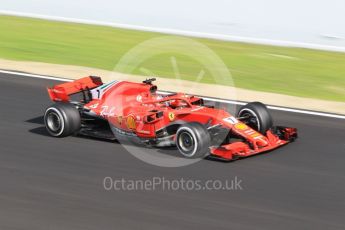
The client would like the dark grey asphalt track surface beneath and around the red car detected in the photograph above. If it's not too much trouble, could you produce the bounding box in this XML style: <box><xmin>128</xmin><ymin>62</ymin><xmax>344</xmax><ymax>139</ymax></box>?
<box><xmin>0</xmin><ymin>74</ymin><xmax>345</xmax><ymax>230</ymax></box>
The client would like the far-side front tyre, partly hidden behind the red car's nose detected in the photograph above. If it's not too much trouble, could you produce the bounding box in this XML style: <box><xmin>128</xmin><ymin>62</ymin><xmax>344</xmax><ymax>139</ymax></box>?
<box><xmin>237</xmin><ymin>102</ymin><xmax>273</xmax><ymax>135</ymax></box>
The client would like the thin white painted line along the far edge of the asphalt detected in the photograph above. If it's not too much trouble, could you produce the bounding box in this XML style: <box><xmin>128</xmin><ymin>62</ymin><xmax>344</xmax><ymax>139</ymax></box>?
<box><xmin>0</xmin><ymin>70</ymin><xmax>345</xmax><ymax>119</ymax></box>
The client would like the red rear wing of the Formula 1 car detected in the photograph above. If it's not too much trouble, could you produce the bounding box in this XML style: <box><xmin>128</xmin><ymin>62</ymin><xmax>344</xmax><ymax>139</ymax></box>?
<box><xmin>47</xmin><ymin>76</ymin><xmax>103</xmax><ymax>102</ymax></box>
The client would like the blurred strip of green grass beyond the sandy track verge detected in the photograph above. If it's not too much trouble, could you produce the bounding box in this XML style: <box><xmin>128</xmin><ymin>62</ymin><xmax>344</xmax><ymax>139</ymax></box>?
<box><xmin>0</xmin><ymin>15</ymin><xmax>345</xmax><ymax>101</ymax></box>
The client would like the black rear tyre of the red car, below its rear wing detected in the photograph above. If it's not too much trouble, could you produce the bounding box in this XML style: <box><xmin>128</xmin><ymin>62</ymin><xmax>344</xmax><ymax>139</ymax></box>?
<box><xmin>44</xmin><ymin>103</ymin><xmax>81</xmax><ymax>137</ymax></box>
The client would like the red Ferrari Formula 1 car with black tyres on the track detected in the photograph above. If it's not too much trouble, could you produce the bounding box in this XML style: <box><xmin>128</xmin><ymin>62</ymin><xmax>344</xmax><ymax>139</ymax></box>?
<box><xmin>44</xmin><ymin>76</ymin><xmax>297</xmax><ymax>160</ymax></box>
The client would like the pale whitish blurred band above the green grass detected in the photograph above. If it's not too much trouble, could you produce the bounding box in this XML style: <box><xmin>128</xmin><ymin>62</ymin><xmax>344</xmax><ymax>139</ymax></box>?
<box><xmin>0</xmin><ymin>0</ymin><xmax>345</xmax><ymax>48</ymax></box>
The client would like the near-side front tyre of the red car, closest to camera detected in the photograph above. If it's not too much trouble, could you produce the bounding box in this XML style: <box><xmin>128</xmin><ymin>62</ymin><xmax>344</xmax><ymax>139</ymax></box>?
<box><xmin>176</xmin><ymin>122</ymin><xmax>211</xmax><ymax>158</ymax></box>
